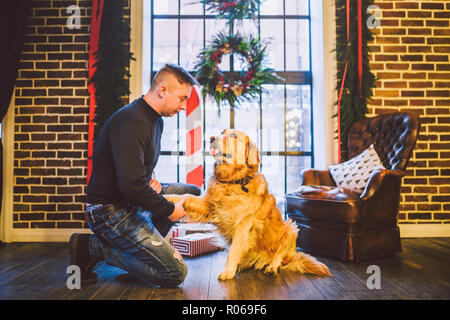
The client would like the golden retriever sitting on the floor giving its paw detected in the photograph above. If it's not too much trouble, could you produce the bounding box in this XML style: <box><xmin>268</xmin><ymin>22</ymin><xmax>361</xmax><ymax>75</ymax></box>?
<box><xmin>165</xmin><ymin>130</ymin><xmax>331</xmax><ymax>280</ymax></box>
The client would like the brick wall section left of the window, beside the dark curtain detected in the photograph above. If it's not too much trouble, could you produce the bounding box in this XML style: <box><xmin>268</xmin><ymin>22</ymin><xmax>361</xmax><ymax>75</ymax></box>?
<box><xmin>13</xmin><ymin>0</ymin><xmax>128</xmax><ymax>228</ymax></box>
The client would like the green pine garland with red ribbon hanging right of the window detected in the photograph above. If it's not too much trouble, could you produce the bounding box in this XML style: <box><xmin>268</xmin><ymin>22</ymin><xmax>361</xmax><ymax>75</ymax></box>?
<box><xmin>336</xmin><ymin>0</ymin><xmax>377</xmax><ymax>161</ymax></box>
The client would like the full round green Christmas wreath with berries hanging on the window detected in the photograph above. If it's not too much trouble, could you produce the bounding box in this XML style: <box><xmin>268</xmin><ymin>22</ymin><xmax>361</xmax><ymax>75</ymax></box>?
<box><xmin>195</xmin><ymin>32</ymin><xmax>282</xmax><ymax>111</ymax></box>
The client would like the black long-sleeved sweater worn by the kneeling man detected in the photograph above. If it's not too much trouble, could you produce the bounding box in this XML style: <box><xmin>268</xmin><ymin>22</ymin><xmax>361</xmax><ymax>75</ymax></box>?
<box><xmin>87</xmin><ymin>97</ymin><xmax>174</xmax><ymax>218</ymax></box>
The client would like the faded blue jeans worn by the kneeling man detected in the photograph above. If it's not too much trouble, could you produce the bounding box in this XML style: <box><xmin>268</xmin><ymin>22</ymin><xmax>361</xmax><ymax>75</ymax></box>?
<box><xmin>88</xmin><ymin>183</ymin><xmax>201</xmax><ymax>287</ymax></box>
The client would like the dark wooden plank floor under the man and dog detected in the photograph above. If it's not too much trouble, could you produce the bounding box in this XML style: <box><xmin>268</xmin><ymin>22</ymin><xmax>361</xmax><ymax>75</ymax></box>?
<box><xmin>0</xmin><ymin>238</ymin><xmax>450</xmax><ymax>300</ymax></box>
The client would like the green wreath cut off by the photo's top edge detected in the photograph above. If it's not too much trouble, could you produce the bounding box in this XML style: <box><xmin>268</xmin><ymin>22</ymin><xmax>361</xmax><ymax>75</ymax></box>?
<box><xmin>200</xmin><ymin>0</ymin><xmax>263</xmax><ymax>21</ymax></box>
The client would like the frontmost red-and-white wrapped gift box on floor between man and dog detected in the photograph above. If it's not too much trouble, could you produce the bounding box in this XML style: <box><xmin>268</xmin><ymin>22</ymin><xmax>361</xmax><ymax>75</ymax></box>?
<box><xmin>171</xmin><ymin>233</ymin><xmax>220</xmax><ymax>257</ymax></box>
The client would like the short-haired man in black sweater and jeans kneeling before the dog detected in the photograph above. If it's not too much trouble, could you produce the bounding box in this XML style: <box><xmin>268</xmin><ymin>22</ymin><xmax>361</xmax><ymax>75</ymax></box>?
<box><xmin>70</xmin><ymin>64</ymin><xmax>201</xmax><ymax>287</ymax></box>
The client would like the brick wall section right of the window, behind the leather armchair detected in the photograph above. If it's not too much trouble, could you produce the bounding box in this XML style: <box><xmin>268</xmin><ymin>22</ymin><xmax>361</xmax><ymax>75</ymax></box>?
<box><xmin>369</xmin><ymin>0</ymin><xmax>450</xmax><ymax>224</ymax></box>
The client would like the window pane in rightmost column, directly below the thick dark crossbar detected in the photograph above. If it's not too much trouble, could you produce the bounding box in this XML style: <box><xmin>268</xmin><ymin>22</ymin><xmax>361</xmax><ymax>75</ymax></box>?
<box><xmin>286</xmin><ymin>85</ymin><xmax>311</xmax><ymax>151</ymax></box>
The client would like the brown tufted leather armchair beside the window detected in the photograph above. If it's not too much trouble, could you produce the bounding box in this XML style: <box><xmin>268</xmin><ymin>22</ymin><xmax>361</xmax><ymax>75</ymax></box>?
<box><xmin>286</xmin><ymin>112</ymin><xmax>420</xmax><ymax>263</ymax></box>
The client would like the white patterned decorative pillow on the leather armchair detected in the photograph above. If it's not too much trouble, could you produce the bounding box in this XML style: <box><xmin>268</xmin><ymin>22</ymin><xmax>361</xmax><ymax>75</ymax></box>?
<box><xmin>328</xmin><ymin>144</ymin><xmax>385</xmax><ymax>193</ymax></box>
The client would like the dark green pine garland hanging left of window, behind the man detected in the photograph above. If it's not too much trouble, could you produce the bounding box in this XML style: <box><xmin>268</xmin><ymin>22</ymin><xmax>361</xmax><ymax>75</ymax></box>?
<box><xmin>90</xmin><ymin>0</ymin><xmax>134</xmax><ymax>140</ymax></box>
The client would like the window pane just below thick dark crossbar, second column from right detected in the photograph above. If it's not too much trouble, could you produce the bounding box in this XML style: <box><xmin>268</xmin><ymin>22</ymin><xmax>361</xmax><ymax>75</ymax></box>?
<box><xmin>262</xmin><ymin>85</ymin><xmax>284</xmax><ymax>151</ymax></box>
